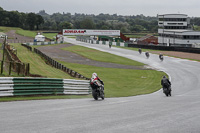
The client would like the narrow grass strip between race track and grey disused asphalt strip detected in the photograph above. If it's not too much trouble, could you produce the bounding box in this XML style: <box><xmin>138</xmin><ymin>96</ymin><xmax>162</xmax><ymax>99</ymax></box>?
<box><xmin>62</xmin><ymin>45</ymin><xmax>144</xmax><ymax>66</ymax></box>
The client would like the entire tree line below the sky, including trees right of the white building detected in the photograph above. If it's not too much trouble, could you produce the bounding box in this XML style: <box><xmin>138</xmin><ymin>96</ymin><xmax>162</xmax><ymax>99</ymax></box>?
<box><xmin>0</xmin><ymin>7</ymin><xmax>200</xmax><ymax>33</ymax></box>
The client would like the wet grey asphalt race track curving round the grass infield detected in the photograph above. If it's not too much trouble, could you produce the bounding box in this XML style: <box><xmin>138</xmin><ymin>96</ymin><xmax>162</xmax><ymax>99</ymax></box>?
<box><xmin>0</xmin><ymin>38</ymin><xmax>200</xmax><ymax>133</ymax></box>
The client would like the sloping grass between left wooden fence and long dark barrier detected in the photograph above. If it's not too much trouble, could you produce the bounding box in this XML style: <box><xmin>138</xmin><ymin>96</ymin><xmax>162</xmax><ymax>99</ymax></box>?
<box><xmin>11</xmin><ymin>43</ymin><xmax>76</xmax><ymax>79</ymax></box>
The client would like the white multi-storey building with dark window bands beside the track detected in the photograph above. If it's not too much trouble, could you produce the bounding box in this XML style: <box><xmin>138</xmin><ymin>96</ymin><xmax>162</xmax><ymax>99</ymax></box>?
<box><xmin>158</xmin><ymin>14</ymin><xmax>200</xmax><ymax>47</ymax></box>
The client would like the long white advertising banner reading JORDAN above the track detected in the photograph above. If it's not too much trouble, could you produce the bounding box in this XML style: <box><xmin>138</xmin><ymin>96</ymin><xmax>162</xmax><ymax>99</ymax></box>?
<box><xmin>63</xmin><ymin>29</ymin><xmax>120</xmax><ymax>36</ymax></box>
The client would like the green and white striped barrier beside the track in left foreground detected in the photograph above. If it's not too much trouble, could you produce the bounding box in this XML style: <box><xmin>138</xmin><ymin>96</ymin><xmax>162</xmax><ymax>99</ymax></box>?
<box><xmin>0</xmin><ymin>77</ymin><xmax>90</xmax><ymax>97</ymax></box>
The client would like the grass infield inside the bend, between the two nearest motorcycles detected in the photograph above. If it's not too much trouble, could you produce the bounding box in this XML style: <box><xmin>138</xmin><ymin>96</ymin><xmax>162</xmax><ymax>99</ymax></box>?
<box><xmin>57</xmin><ymin>61</ymin><xmax>166</xmax><ymax>97</ymax></box>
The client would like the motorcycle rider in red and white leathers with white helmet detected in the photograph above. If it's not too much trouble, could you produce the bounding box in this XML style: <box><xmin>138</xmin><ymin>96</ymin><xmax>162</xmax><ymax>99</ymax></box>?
<box><xmin>90</xmin><ymin>73</ymin><xmax>104</xmax><ymax>89</ymax></box>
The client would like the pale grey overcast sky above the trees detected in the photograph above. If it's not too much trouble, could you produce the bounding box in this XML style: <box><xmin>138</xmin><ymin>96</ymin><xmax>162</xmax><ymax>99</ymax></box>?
<box><xmin>0</xmin><ymin>0</ymin><xmax>200</xmax><ymax>17</ymax></box>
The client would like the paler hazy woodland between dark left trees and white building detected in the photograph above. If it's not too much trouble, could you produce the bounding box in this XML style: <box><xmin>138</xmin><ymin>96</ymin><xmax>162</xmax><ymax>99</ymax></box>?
<box><xmin>38</xmin><ymin>10</ymin><xmax>158</xmax><ymax>33</ymax></box>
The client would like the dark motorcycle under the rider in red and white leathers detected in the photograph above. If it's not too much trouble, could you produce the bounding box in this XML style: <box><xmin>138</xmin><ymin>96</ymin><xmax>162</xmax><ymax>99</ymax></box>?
<box><xmin>91</xmin><ymin>81</ymin><xmax>104</xmax><ymax>100</ymax></box>
